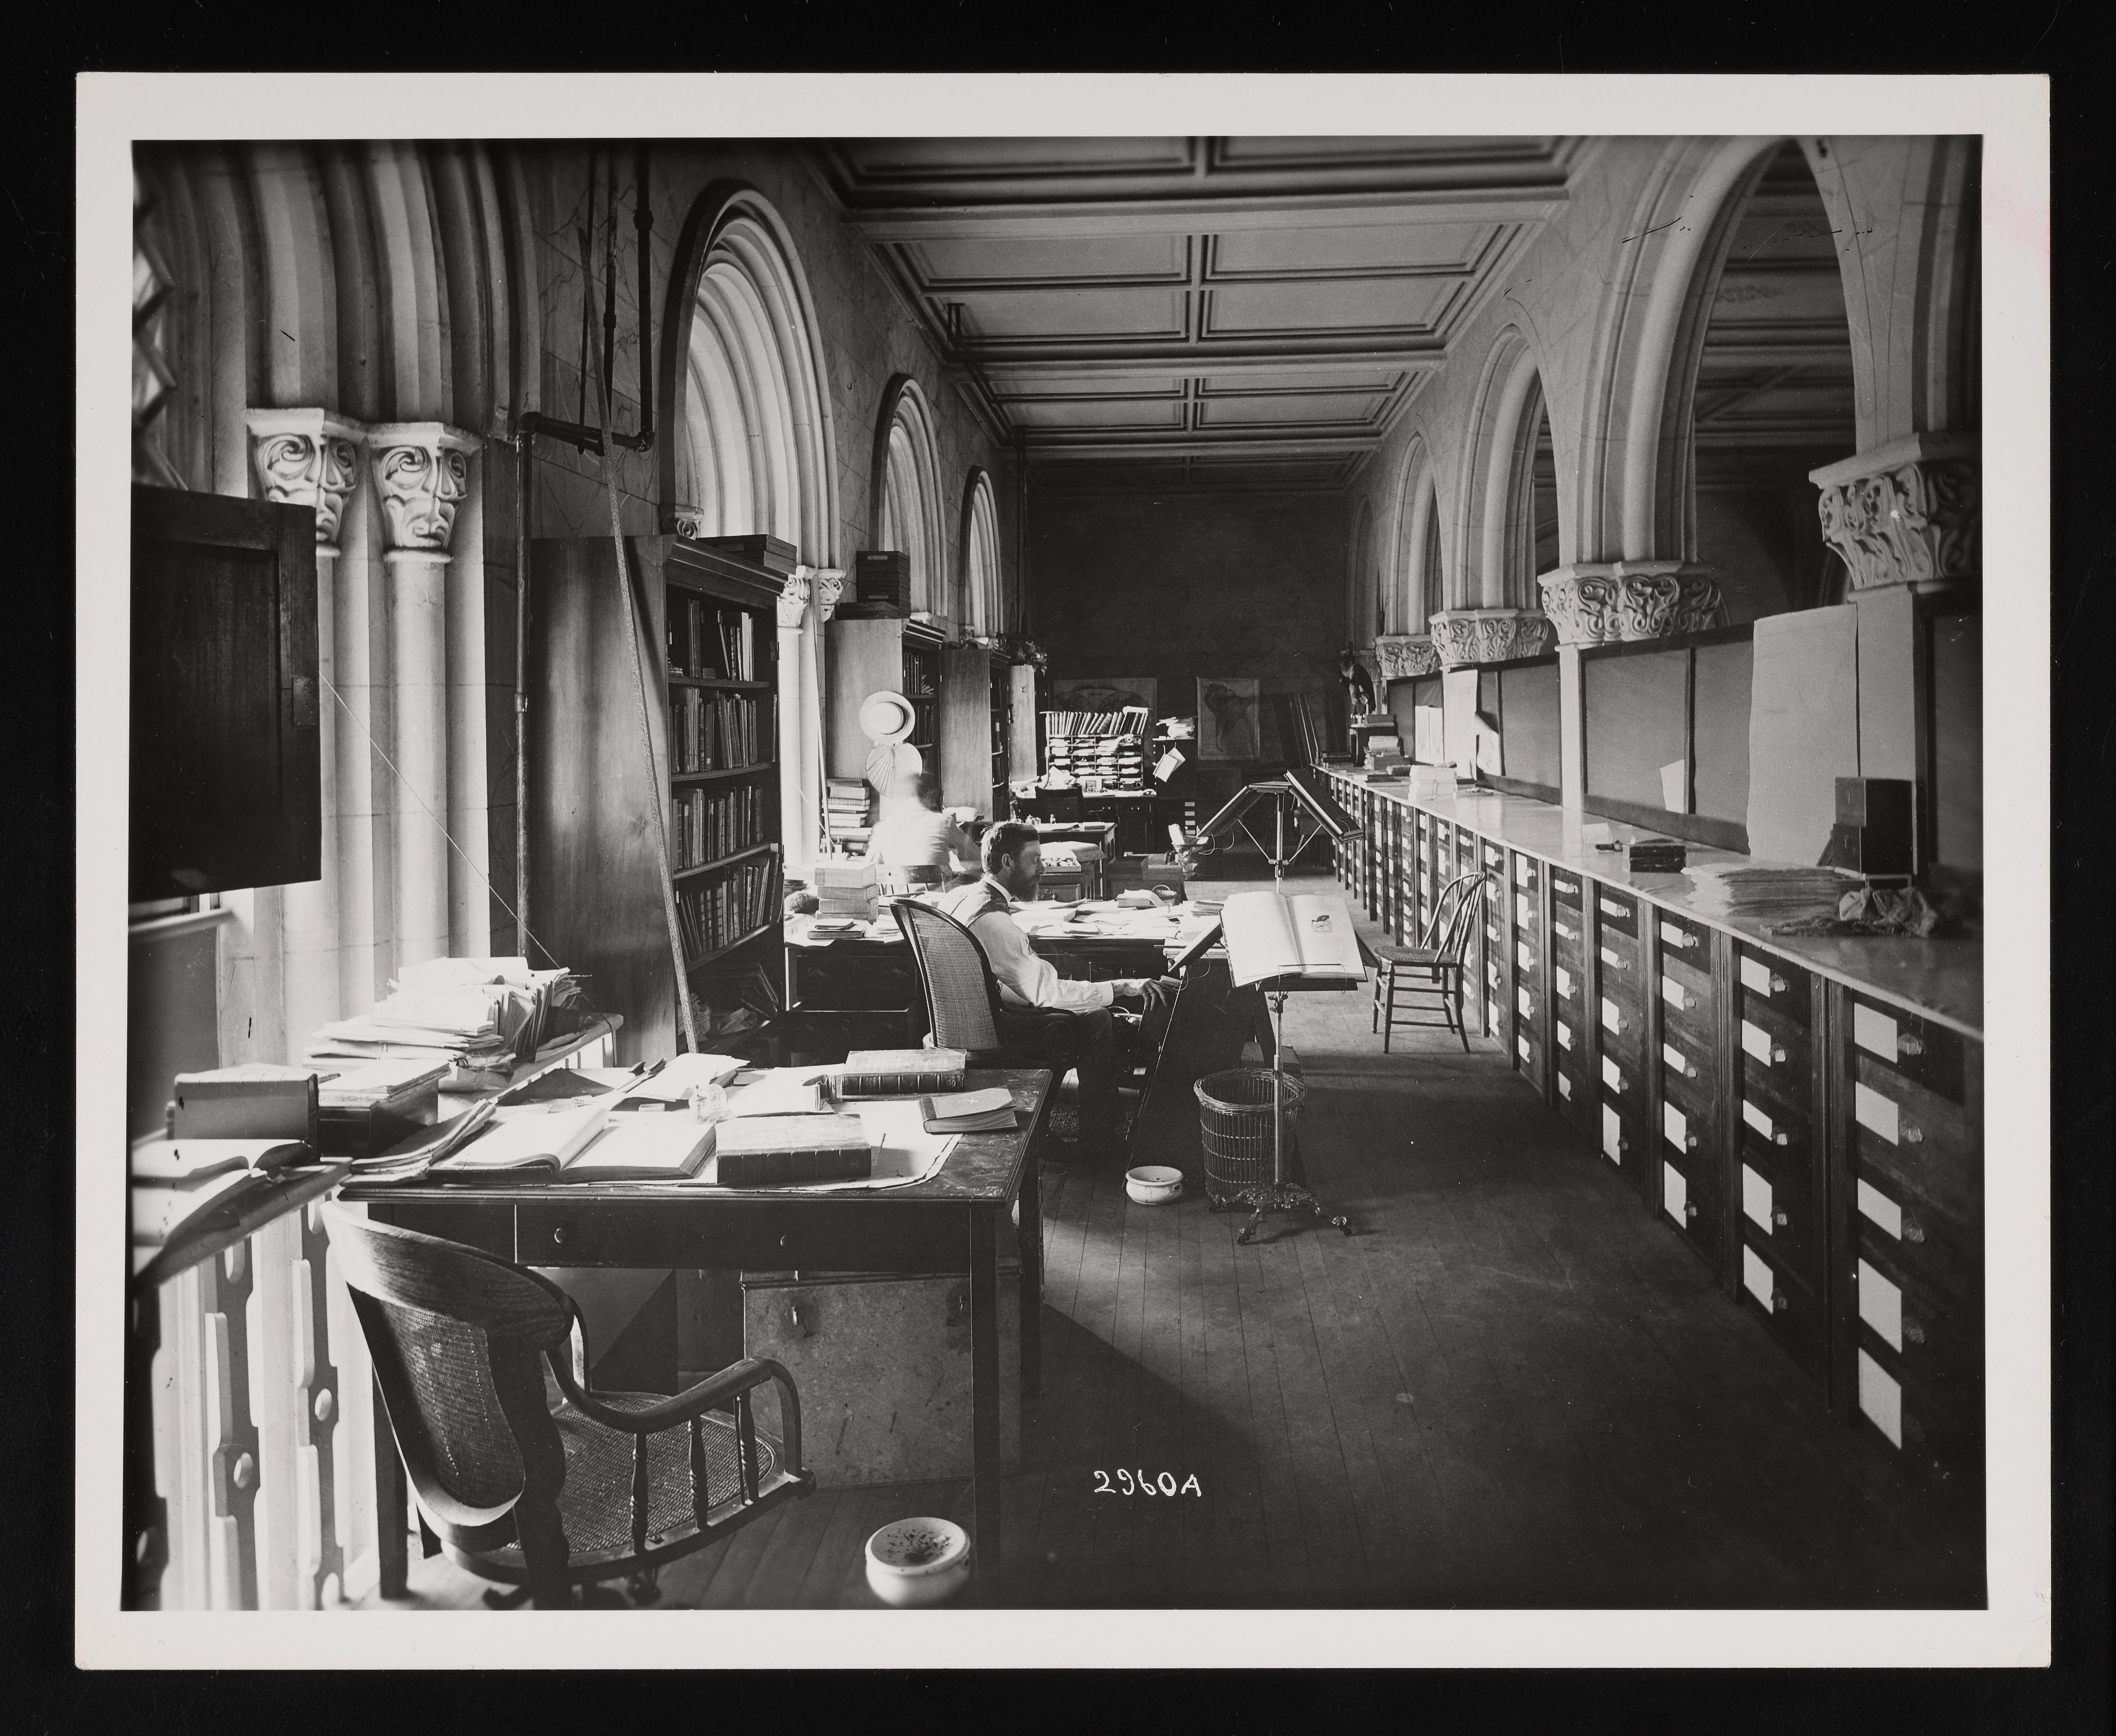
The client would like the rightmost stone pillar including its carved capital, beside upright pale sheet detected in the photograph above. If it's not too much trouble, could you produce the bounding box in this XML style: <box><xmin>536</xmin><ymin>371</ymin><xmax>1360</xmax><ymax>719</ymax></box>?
<box><xmin>1809</xmin><ymin>434</ymin><xmax>1983</xmax><ymax>797</ymax></box>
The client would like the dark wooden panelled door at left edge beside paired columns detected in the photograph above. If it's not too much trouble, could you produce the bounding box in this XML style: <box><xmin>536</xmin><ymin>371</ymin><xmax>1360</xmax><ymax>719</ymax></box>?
<box><xmin>129</xmin><ymin>486</ymin><xmax>324</xmax><ymax>901</ymax></box>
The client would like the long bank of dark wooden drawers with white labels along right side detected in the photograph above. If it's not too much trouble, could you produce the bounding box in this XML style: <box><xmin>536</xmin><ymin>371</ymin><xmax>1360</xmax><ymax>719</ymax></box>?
<box><xmin>1331</xmin><ymin>772</ymin><xmax>1985</xmax><ymax>1539</ymax></box>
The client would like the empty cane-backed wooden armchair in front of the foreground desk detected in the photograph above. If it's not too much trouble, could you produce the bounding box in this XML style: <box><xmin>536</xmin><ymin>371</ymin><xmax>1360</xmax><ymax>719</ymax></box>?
<box><xmin>324</xmin><ymin>1205</ymin><xmax>815</xmax><ymax>1609</ymax></box>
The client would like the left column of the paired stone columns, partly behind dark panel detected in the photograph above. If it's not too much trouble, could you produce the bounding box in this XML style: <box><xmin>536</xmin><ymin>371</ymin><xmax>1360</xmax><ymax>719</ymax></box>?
<box><xmin>248</xmin><ymin>408</ymin><xmax>366</xmax><ymax>1059</ymax></box>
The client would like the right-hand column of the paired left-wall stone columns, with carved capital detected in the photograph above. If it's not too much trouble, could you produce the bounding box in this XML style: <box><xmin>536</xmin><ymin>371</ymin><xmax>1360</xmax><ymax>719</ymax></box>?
<box><xmin>368</xmin><ymin>423</ymin><xmax>478</xmax><ymax>966</ymax></box>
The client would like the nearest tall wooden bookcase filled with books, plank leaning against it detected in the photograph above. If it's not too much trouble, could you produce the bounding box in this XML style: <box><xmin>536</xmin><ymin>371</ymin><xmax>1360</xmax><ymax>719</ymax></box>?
<box><xmin>529</xmin><ymin>537</ymin><xmax>783</xmax><ymax>1063</ymax></box>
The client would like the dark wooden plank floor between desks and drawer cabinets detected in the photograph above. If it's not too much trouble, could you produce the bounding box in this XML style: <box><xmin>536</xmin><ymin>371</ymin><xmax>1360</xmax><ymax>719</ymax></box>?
<box><xmin>355</xmin><ymin>862</ymin><xmax>1983</xmax><ymax>1609</ymax></box>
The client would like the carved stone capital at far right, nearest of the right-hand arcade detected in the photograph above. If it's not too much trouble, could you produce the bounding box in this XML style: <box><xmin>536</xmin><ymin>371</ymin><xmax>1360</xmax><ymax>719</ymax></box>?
<box><xmin>1807</xmin><ymin>434</ymin><xmax>1983</xmax><ymax>590</ymax></box>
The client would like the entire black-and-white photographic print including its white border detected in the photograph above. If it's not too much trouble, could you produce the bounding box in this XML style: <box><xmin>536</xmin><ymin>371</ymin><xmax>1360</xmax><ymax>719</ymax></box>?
<box><xmin>76</xmin><ymin>74</ymin><xmax>2050</xmax><ymax>1668</ymax></box>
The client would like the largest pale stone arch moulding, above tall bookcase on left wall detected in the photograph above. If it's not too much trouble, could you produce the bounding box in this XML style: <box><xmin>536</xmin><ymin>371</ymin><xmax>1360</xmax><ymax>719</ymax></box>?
<box><xmin>656</xmin><ymin>180</ymin><xmax>838</xmax><ymax>567</ymax></box>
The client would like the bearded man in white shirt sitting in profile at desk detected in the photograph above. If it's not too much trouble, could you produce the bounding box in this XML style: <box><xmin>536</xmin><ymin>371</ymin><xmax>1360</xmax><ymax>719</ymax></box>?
<box><xmin>937</xmin><ymin>821</ymin><xmax>1181</xmax><ymax>1154</ymax></box>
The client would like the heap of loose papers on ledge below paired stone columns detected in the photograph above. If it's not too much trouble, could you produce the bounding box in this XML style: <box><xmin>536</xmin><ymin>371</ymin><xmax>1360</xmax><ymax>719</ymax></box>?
<box><xmin>309</xmin><ymin>958</ymin><xmax>578</xmax><ymax>1089</ymax></box>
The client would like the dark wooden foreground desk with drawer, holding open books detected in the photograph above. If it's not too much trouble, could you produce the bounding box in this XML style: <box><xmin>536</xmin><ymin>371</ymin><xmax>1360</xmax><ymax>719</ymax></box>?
<box><xmin>343</xmin><ymin>1070</ymin><xmax>1054</xmax><ymax>1597</ymax></box>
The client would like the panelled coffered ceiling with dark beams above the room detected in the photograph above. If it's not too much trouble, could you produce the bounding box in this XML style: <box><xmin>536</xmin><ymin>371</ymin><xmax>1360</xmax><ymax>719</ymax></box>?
<box><xmin>817</xmin><ymin>138</ymin><xmax>1583</xmax><ymax>493</ymax></box>
